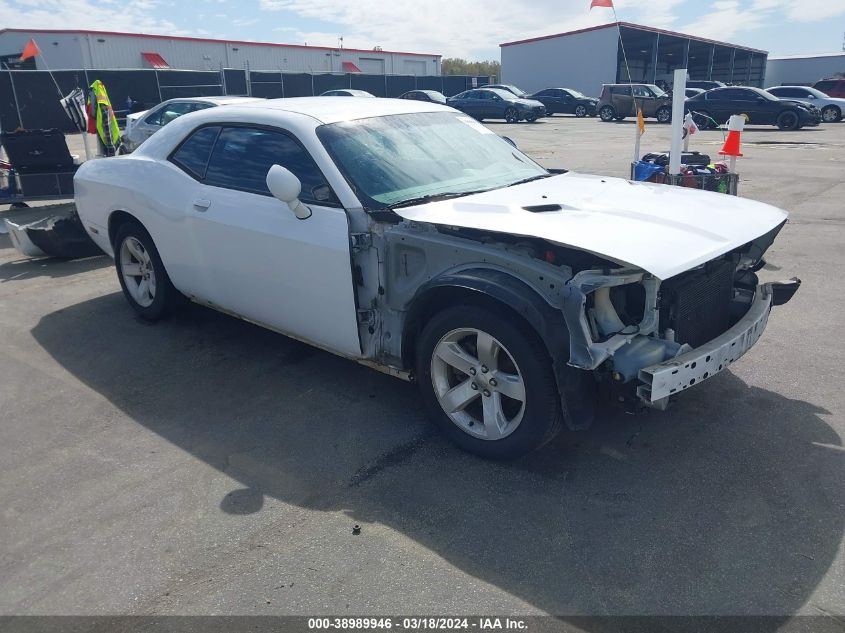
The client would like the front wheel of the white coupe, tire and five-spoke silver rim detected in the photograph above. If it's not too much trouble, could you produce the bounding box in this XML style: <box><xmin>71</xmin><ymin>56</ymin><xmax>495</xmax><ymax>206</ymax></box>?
<box><xmin>416</xmin><ymin>305</ymin><xmax>562</xmax><ymax>459</ymax></box>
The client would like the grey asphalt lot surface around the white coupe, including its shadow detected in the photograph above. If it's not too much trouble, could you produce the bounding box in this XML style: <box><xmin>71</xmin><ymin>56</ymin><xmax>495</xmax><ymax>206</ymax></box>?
<box><xmin>0</xmin><ymin>117</ymin><xmax>845</xmax><ymax>616</ymax></box>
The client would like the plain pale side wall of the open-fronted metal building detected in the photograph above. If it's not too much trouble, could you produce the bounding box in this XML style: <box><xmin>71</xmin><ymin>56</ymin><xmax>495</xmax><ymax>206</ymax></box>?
<box><xmin>501</xmin><ymin>29</ymin><xmax>619</xmax><ymax>96</ymax></box>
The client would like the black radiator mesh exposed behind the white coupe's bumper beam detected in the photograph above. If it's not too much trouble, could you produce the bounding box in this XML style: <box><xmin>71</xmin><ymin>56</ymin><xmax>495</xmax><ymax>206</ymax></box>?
<box><xmin>660</xmin><ymin>260</ymin><xmax>735</xmax><ymax>347</ymax></box>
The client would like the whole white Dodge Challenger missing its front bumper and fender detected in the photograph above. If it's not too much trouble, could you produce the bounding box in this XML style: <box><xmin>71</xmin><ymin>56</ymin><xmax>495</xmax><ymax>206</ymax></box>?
<box><xmin>75</xmin><ymin>97</ymin><xmax>800</xmax><ymax>458</ymax></box>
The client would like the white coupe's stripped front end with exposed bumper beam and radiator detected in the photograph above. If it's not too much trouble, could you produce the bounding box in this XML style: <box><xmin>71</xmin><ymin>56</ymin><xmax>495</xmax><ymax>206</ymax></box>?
<box><xmin>564</xmin><ymin>225</ymin><xmax>801</xmax><ymax>409</ymax></box>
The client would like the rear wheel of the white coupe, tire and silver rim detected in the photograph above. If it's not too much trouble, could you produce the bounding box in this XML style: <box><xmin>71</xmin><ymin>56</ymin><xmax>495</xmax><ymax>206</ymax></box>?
<box><xmin>114</xmin><ymin>222</ymin><xmax>183</xmax><ymax>321</ymax></box>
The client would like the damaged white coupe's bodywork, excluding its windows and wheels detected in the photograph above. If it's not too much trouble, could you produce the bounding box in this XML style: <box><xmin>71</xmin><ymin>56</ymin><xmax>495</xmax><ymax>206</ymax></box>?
<box><xmin>75</xmin><ymin>97</ymin><xmax>794</xmax><ymax>450</ymax></box>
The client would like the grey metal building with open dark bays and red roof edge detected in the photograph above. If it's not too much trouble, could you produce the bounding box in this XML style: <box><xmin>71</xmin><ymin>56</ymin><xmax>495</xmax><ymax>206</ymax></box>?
<box><xmin>501</xmin><ymin>22</ymin><xmax>768</xmax><ymax>95</ymax></box>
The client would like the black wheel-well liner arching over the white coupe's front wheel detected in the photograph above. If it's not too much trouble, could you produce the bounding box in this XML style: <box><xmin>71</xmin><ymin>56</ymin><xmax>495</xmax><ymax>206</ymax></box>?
<box><xmin>402</xmin><ymin>286</ymin><xmax>546</xmax><ymax>371</ymax></box>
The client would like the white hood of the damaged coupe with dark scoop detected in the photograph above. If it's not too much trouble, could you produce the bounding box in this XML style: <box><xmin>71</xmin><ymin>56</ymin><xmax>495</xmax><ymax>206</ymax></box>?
<box><xmin>396</xmin><ymin>172</ymin><xmax>788</xmax><ymax>279</ymax></box>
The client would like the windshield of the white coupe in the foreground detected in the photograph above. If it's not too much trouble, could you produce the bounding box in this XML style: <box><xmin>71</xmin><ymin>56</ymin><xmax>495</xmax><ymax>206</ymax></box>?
<box><xmin>317</xmin><ymin>112</ymin><xmax>548</xmax><ymax>209</ymax></box>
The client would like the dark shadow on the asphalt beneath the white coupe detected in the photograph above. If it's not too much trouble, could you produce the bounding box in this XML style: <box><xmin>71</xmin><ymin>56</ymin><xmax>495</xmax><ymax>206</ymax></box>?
<box><xmin>32</xmin><ymin>293</ymin><xmax>845</xmax><ymax>616</ymax></box>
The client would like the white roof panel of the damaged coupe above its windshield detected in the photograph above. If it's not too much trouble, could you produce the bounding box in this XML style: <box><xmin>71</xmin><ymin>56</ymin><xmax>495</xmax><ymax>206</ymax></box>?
<box><xmin>229</xmin><ymin>97</ymin><xmax>454</xmax><ymax>123</ymax></box>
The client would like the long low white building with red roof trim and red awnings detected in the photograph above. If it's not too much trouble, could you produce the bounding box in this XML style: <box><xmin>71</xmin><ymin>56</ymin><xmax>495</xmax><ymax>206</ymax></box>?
<box><xmin>0</xmin><ymin>29</ymin><xmax>441</xmax><ymax>76</ymax></box>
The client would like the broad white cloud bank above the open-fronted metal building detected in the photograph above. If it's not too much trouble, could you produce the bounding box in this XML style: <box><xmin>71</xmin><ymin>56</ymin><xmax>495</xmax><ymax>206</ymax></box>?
<box><xmin>259</xmin><ymin>0</ymin><xmax>845</xmax><ymax>58</ymax></box>
